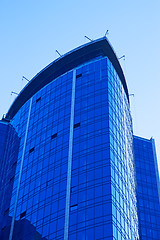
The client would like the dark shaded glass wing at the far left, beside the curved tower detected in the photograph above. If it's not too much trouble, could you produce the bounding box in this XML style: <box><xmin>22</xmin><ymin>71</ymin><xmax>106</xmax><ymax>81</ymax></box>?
<box><xmin>0</xmin><ymin>121</ymin><xmax>19</xmax><ymax>239</ymax></box>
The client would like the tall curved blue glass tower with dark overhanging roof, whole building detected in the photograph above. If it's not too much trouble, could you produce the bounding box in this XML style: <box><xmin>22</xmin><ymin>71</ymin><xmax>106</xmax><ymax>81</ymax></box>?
<box><xmin>0</xmin><ymin>38</ymin><xmax>158</xmax><ymax>240</ymax></box>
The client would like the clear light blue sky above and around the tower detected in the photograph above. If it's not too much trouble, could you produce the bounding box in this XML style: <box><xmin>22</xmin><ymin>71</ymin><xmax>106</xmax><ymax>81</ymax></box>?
<box><xmin>0</xmin><ymin>0</ymin><xmax>160</xmax><ymax>169</ymax></box>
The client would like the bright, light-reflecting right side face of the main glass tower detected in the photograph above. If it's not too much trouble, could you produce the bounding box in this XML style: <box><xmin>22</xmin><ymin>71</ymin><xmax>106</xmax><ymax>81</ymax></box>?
<box><xmin>108</xmin><ymin>58</ymin><xmax>138</xmax><ymax>239</ymax></box>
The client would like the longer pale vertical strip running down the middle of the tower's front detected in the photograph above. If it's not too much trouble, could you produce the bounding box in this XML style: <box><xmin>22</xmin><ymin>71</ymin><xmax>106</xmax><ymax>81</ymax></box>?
<box><xmin>64</xmin><ymin>69</ymin><xmax>76</xmax><ymax>240</ymax></box>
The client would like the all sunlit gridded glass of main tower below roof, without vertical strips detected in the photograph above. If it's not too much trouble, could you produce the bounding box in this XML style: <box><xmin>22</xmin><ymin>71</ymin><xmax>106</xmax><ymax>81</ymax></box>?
<box><xmin>5</xmin><ymin>57</ymin><xmax>138</xmax><ymax>240</ymax></box>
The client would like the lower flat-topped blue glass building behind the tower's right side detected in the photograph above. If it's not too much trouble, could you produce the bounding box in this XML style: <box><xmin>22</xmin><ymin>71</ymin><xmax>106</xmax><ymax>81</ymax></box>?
<box><xmin>134</xmin><ymin>136</ymin><xmax>160</xmax><ymax>240</ymax></box>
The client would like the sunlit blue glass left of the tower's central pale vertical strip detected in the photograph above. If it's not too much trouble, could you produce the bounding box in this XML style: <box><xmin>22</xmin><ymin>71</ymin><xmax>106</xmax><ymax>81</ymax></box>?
<box><xmin>9</xmin><ymin>73</ymin><xmax>73</xmax><ymax>239</ymax></box>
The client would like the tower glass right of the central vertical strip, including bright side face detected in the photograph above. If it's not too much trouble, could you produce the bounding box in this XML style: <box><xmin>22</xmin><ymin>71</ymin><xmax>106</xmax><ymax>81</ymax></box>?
<box><xmin>69</xmin><ymin>58</ymin><xmax>138</xmax><ymax>240</ymax></box>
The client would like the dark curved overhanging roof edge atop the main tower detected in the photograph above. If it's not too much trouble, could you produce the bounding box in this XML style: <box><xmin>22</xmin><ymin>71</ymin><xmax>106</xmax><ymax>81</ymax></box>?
<box><xmin>5</xmin><ymin>37</ymin><xmax>129</xmax><ymax>120</ymax></box>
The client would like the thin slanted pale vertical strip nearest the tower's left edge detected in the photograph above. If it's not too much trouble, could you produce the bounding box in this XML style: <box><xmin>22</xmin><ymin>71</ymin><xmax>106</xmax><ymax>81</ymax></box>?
<box><xmin>9</xmin><ymin>98</ymin><xmax>32</xmax><ymax>240</ymax></box>
